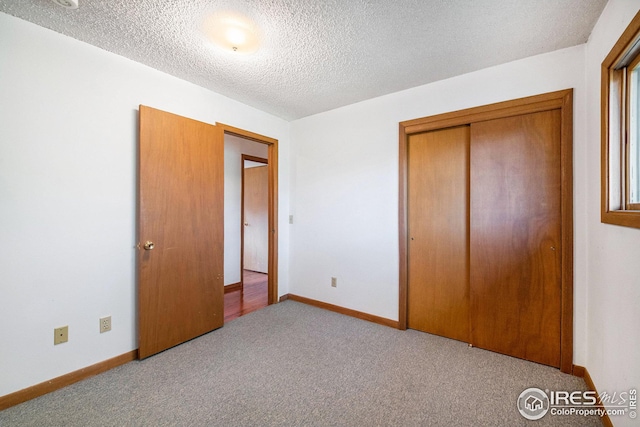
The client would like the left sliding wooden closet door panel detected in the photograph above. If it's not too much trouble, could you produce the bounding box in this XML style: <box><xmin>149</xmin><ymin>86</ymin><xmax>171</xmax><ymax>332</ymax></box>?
<box><xmin>407</xmin><ymin>126</ymin><xmax>469</xmax><ymax>342</ymax></box>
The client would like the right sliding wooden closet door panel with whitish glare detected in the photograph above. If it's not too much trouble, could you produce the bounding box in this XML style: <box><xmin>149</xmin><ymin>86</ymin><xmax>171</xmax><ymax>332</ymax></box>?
<box><xmin>470</xmin><ymin>110</ymin><xmax>562</xmax><ymax>367</ymax></box>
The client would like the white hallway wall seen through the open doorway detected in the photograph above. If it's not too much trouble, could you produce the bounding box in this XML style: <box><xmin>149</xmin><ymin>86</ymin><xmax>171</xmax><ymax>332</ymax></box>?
<box><xmin>224</xmin><ymin>135</ymin><xmax>269</xmax><ymax>286</ymax></box>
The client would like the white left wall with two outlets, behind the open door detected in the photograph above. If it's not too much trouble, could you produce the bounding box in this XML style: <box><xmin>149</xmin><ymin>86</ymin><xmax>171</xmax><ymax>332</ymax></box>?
<box><xmin>0</xmin><ymin>13</ymin><xmax>289</xmax><ymax>396</ymax></box>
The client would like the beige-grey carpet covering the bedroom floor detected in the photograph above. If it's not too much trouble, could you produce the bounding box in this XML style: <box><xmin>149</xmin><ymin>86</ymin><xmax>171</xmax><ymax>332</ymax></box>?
<box><xmin>0</xmin><ymin>301</ymin><xmax>602</xmax><ymax>427</ymax></box>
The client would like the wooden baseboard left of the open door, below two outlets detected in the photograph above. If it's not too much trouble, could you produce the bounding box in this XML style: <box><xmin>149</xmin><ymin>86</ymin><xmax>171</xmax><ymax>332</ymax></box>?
<box><xmin>0</xmin><ymin>350</ymin><xmax>138</xmax><ymax>411</ymax></box>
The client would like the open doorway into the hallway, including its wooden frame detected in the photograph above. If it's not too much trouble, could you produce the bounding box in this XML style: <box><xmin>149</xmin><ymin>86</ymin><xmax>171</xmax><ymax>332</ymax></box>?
<box><xmin>219</xmin><ymin>125</ymin><xmax>277</xmax><ymax>322</ymax></box>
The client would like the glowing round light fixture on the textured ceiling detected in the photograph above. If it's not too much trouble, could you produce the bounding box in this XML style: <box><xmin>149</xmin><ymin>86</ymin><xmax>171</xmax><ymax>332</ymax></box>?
<box><xmin>203</xmin><ymin>14</ymin><xmax>260</xmax><ymax>54</ymax></box>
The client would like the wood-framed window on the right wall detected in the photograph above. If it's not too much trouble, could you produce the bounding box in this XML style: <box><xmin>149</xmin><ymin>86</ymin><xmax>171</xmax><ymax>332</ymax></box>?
<box><xmin>602</xmin><ymin>12</ymin><xmax>640</xmax><ymax>228</ymax></box>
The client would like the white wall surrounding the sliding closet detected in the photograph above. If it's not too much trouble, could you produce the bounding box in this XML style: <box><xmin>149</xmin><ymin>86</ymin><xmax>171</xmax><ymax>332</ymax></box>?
<box><xmin>291</xmin><ymin>46</ymin><xmax>586</xmax><ymax>334</ymax></box>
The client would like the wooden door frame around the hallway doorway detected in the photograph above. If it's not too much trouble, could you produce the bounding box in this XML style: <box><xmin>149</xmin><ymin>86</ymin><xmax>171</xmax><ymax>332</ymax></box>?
<box><xmin>216</xmin><ymin>123</ymin><xmax>278</xmax><ymax>304</ymax></box>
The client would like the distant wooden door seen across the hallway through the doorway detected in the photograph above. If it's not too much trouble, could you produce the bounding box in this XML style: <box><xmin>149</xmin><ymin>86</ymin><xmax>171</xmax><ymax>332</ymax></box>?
<box><xmin>243</xmin><ymin>165</ymin><xmax>269</xmax><ymax>273</ymax></box>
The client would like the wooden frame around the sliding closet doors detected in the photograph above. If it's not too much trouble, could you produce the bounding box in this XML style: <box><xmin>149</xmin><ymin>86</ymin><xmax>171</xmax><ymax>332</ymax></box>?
<box><xmin>398</xmin><ymin>89</ymin><xmax>573</xmax><ymax>373</ymax></box>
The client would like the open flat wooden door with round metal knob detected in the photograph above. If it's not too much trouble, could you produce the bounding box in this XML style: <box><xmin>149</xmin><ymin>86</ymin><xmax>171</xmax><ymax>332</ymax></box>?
<box><xmin>138</xmin><ymin>106</ymin><xmax>224</xmax><ymax>358</ymax></box>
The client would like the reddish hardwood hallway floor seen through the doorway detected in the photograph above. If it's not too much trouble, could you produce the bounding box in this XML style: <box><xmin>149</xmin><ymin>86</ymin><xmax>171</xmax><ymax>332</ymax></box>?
<box><xmin>224</xmin><ymin>270</ymin><xmax>269</xmax><ymax>323</ymax></box>
